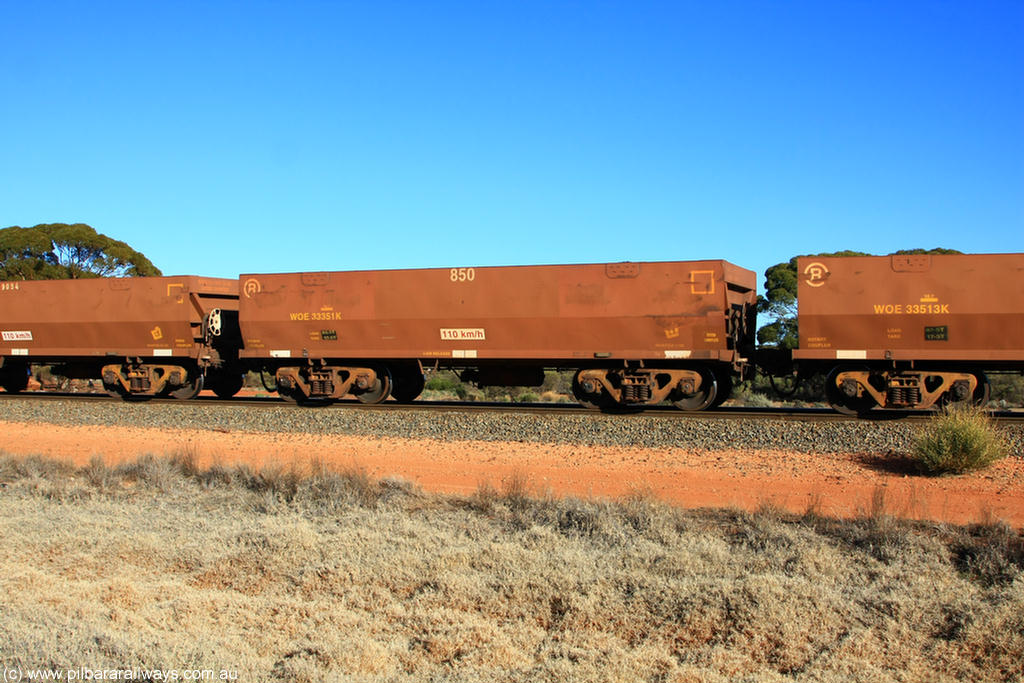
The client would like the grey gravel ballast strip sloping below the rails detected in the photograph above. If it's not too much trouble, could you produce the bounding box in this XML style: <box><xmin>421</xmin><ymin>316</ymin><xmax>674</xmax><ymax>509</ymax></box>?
<box><xmin>0</xmin><ymin>396</ymin><xmax>1024</xmax><ymax>457</ymax></box>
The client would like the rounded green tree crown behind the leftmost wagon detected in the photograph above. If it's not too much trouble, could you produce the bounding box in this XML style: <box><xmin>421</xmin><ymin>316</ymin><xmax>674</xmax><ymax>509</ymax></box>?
<box><xmin>0</xmin><ymin>223</ymin><xmax>161</xmax><ymax>280</ymax></box>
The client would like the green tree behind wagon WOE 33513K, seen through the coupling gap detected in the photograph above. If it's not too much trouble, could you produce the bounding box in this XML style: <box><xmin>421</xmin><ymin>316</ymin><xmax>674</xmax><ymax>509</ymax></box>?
<box><xmin>758</xmin><ymin>249</ymin><xmax>961</xmax><ymax>348</ymax></box>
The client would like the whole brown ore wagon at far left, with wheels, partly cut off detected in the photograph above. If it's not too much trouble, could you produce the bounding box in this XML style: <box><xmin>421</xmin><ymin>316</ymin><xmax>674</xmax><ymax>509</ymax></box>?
<box><xmin>0</xmin><ymin>276</ymin><xmax>243</xmax><ymax>398</ymax></box>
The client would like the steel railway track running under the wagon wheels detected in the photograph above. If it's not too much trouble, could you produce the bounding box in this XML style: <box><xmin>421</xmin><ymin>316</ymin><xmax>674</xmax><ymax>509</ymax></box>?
<box><xmin>0</xmin><ymin>391</ymin><xmax>1024</xmax><ymax>424</ymax></box>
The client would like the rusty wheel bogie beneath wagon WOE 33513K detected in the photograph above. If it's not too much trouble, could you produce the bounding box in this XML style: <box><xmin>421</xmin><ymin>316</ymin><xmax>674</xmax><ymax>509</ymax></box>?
<box><xmin>828</xmin><ymin>370</ymin><xmax>987</xmax><ymax>412</ymax></box>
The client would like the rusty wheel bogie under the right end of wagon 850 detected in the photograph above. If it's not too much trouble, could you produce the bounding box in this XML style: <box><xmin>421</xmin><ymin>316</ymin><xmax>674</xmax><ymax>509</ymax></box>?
<box><xmin>573</xmin><ymin>368</ymin><xmax>708</xmax><ymax>408</ymax></box>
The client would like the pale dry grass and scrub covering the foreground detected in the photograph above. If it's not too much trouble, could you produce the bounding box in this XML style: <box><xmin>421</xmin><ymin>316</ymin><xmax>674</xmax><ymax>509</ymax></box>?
<box><xmin>0</xmin><ymin>454</ymin><xmax>1024</xmax><ymax>682</ymax></box>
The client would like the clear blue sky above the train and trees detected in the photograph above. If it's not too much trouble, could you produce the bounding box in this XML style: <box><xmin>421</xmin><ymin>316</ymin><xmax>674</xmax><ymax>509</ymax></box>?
<box><xmin>0</xmin><ymin>0</ymin><xmax>1024</xmax><ymax>276</ymax></box>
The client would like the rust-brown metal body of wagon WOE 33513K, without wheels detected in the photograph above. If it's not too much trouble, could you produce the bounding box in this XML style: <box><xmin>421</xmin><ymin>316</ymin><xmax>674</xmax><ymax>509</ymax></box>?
<box><xmin>794</xmin><ymin>254</ymin><xmax>1024</xmax><ymax>365</ymax></box>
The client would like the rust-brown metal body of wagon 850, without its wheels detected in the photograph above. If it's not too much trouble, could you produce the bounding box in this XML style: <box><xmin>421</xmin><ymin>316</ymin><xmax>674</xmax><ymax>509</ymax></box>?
<box><xmin>240</xmin><ymin>260</ymin><xmax>757</xmax><ymax>366</ymax></box>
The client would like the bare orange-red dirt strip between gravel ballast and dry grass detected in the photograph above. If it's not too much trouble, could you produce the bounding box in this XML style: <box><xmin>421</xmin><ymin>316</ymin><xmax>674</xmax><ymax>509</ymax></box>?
<box><xmin>0</xmin><ymin>422</ymin><xmax>1024</xmax><ymax>527</ymax></box>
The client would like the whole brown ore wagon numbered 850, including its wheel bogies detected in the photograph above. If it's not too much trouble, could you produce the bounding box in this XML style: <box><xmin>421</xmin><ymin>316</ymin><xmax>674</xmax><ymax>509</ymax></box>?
<box><xmin>239</xmin><ymin>260</ymin><xmax>757</xmax><ymax>411</ymax></box>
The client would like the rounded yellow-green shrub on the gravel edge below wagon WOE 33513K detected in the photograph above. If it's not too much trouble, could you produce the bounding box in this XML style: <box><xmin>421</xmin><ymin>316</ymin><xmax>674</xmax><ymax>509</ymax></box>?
<box><xmin>911</xmin><ymin>407</ymin><xmax>1007</xmax><ymax>474</ymax></box>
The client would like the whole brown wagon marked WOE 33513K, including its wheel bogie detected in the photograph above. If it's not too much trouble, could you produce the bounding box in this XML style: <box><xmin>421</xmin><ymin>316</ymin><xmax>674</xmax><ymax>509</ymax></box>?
<box><xmin>793</xmin><ymin>254</ymin><xmax>1024</xmax><ymax>414</ymax></box>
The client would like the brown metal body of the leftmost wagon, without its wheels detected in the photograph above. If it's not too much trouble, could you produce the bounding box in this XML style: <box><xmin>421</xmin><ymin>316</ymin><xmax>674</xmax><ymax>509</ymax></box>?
<box><xmin>0</xmin><ymin>275</ymin><xmax>239</xmax><ymax>367</ymax></box>
